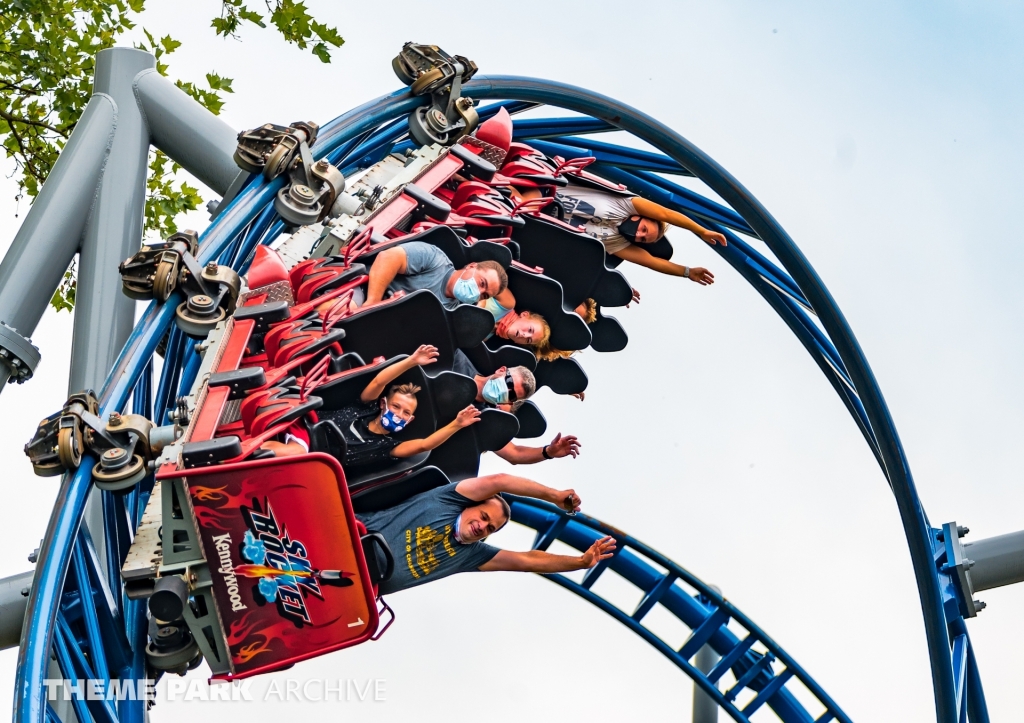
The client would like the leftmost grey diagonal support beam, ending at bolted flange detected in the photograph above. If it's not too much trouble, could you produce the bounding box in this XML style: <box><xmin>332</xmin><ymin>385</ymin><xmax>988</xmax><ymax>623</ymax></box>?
<box><xmin>0</xmin><ymin>93</ymin><xmax>118</xmax><ymax>390</ymax></box>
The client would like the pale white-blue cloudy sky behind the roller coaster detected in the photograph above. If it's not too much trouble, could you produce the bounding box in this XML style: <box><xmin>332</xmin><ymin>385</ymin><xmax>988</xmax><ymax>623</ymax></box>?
<box><xmin>0</xmin><ymin>0</ymin><xmax>1024</xmax><ymax>723</ymax></box>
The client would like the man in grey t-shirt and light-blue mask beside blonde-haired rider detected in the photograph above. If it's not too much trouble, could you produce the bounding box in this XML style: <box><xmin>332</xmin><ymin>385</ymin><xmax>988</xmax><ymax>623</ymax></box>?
<box><xmin>366</xmin><ymin>241</ymin><xmax>509</xmax><ymax>309</ymax></box>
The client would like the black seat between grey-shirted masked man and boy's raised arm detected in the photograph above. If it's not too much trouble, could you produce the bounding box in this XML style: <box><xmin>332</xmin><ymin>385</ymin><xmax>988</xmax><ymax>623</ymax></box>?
<box><xmin>327</xmin><ymin>289</ymin><xmax>494</xmax><ymax>370</ymax></box>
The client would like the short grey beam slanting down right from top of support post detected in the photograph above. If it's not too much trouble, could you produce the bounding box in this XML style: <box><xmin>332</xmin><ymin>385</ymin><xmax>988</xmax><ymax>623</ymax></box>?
<box><xmin>135</xmin><ymin>70</ymin><xmax>241</xmax><ymax>196</ymax></box>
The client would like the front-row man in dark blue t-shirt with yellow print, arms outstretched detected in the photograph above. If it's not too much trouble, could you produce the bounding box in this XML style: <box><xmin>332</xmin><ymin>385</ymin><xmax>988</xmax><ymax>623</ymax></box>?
<box><xmin>356</xmin><ymin>474</ymin><xmax>615</xmax><ymax>595</ymax></box>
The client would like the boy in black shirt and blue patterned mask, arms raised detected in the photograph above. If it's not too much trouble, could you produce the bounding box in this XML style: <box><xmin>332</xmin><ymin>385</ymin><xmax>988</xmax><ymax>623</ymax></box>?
<box><xmin>262</xmin><ymin>344</ymin><xmax>480</xmax><ymax>474</ymax></box>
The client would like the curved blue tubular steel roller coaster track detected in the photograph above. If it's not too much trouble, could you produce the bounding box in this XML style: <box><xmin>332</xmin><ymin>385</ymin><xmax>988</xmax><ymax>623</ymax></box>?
<box><xmin>14</xmin><ymin>77</ymin><xmax>988</xmax><ymax>723</ymax></box>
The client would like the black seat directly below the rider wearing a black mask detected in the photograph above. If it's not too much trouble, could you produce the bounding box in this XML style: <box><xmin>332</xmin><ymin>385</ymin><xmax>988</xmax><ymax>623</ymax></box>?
<box><xmin>512</xmin><ymin>216</ymin><xmax>633</xmax><ymax>308</ymax></box>
